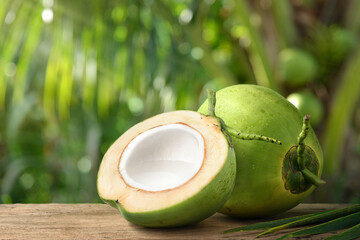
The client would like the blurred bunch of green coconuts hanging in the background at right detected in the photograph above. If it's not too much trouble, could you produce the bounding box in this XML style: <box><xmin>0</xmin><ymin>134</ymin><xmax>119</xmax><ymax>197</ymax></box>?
<box><xmin>276</xmin><ymin>24</ymin><xmax>356</xmax><ymax>128</ymax></box>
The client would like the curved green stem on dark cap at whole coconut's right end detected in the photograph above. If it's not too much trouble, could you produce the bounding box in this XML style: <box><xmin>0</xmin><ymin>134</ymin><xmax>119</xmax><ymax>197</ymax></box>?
<box><xmin>297</xmin><ymin>114</ymin><xmax>325</xmax><ymax>186</ymax></box>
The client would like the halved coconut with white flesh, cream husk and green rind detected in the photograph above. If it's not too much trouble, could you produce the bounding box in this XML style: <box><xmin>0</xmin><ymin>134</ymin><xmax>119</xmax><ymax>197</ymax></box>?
<box><xmin>97</xmin><ymin>111</ymin><xmax>236</xmax><ymax>227</ymax></box>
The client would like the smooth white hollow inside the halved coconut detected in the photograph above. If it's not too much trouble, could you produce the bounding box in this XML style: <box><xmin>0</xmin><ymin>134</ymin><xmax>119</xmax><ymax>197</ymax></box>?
<box><xmin>119</xmin><ymin>124</ymin><xmax>205</xmax><ymax>191</ymax></box>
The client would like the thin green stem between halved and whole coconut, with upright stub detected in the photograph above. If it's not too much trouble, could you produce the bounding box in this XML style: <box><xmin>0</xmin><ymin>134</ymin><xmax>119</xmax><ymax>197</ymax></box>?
<box><xmin>207</xmin><ymin>89</ymin><xmax>281</xmax><ymax>145</ymax></box>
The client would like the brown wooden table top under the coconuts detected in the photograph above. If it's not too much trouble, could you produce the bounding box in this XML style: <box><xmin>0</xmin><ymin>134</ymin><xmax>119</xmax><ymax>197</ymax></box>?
<box><xmin>0</xmin><ymin>204</ymin><xmax>344</xmax><ymax>239</ymax></box>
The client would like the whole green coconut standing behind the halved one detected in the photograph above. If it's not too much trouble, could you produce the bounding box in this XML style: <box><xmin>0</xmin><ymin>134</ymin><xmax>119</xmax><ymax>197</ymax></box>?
<box><xmin>199</xmin><ymin>85</ymin><xmax>323</xmax><ymax>218</ymax></box>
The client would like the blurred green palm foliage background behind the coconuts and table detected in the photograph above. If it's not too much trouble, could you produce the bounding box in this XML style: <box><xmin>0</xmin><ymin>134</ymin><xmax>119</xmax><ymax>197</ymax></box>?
<box><xmin>0</xmin><ymin>0</ymin><xmax>360</xmax><ymax>203</ymax></box>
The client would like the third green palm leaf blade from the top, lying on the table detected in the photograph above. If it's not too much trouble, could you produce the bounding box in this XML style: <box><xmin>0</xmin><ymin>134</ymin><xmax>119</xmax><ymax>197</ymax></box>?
<box><xmin>279</xmin><ymin>212</ymin><xmax>360</xmax><ymax>239</ymax></box>
